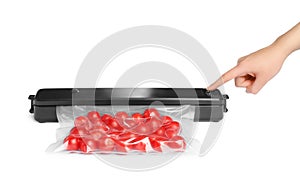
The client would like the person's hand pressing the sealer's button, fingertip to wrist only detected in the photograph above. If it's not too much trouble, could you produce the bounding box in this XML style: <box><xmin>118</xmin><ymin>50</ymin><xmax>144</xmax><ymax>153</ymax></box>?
<box><xmin>207</xmin><ymin>44</ymin><xmax>287</xmax><ymax>94</ymax></box>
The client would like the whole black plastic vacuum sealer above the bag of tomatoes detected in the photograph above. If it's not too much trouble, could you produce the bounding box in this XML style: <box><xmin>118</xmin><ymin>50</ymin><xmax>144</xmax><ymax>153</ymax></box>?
<box><xmin>28</xmin><ymin>88</ymin><xmax>229</xmax><ymax>123</ymax></box>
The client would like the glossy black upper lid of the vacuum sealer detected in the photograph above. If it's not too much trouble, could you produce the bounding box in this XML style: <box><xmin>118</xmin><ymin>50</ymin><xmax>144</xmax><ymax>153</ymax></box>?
<box><xmin>30</xmin><ymin>88</ymin><xmax>228</xmax><ymax>109</ymax></box>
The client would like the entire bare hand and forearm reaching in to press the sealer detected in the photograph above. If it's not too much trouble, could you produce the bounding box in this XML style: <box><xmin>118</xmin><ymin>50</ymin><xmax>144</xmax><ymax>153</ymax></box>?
<box><xmin>207</xmin><ymin>23</ymin><xmax>300</xmax><ymax>94</ymax></box>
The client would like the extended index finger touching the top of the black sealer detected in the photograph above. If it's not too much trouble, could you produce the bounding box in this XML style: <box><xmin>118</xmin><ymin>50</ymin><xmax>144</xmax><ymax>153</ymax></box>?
<box><xmin>207</xmin><ymin>66</ymin><xmax>243</xmax><ymax>90</ymax></box>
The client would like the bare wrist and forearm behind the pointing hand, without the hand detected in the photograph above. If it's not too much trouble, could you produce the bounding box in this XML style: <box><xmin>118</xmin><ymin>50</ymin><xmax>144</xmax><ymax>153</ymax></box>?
<box><xmin>273</xmin><ymin>22</ymin><xmax>300</xmax><ymax>56</ymax></box>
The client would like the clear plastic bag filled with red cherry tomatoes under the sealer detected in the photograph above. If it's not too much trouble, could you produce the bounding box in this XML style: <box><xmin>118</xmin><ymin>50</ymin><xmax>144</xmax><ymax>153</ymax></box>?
<box><xmin>48</xmin><ymin>105</ymin><xmax>200</xmax><ymax>155</ymax></box>
